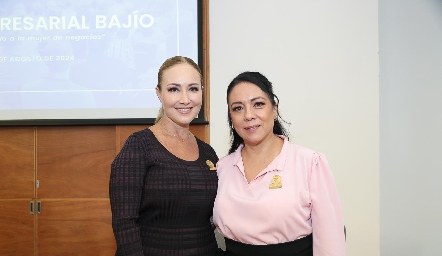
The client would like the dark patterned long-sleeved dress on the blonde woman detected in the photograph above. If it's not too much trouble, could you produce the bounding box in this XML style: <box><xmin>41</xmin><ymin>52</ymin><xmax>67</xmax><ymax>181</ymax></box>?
<box><xmin>109</xmin><ymin>129</ymin><xmax>218</xmax><ymax>256</ymax></box>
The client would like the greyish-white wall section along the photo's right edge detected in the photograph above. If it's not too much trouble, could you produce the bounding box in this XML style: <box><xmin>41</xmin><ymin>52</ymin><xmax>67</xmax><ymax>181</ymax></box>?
<box><xmin>379</xmin><ymin>0</ymin><xmax>442</xmax><ymax>256</ymax></box>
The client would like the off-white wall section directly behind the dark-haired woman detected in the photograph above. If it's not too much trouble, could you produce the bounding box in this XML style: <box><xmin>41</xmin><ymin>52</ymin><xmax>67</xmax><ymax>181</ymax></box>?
<box><xmin>209</xmin><ymin>0</ymin><xmax>380</xmax><ymax>256</ymax></box>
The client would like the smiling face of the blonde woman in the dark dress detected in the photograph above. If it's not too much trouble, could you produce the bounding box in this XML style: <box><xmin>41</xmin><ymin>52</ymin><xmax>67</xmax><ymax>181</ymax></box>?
<box><xmin>156</xmin><ymin>63</ymin><xmax>203</xmax><ymax>126</ymax></box>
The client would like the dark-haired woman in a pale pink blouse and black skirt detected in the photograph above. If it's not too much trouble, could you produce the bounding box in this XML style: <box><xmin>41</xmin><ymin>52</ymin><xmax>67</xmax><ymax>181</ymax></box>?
<box><xmin>213</xmin><ymin>72</ymin><xmax>345</xmax><ymax>256</ymax></box>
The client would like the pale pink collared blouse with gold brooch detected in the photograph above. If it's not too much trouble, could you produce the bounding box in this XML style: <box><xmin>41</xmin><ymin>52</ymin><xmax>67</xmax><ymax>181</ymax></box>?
<box><xmin>213</xmin><ymin>136</ymin><xmax>345</xmax><ymax>256</ymax></box>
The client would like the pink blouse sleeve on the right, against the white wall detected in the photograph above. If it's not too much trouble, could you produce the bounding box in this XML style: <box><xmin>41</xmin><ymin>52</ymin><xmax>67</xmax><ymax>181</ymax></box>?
<box><xmin>310</xmin><ymin>153</ymin><xmax>345</xmax><ymax>256</ymax></box>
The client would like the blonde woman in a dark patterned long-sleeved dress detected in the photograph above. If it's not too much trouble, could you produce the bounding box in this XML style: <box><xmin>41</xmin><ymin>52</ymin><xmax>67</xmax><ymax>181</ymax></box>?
<box><xmin>109</xmin><ymin>56</ymin><xmax>218</xmax><ymax>256</ymax></box>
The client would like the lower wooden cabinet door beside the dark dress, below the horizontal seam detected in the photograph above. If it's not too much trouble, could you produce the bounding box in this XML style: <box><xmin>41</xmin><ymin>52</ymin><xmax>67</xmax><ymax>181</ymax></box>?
<box><xmin>37</xmin><ymin>199</ymin><xmax>116</xmax><ymax>256</ymax></box>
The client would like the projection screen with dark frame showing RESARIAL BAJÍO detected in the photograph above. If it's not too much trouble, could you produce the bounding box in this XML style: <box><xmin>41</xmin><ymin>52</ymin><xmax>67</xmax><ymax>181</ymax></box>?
<box><xmin>0</xmin><ymin>0</ymin><xmax>204</xmax><ymax>125</ymax></box>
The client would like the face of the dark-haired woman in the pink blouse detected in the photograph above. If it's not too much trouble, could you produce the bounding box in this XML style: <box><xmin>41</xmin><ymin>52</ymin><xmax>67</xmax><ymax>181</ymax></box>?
<box><xmin>228</xmin><ymin>82</ymin><xmax>278</xmax><ymax>146</ymax></box>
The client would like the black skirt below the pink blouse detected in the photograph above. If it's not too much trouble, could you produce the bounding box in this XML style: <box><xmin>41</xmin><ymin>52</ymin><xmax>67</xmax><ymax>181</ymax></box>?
<box><xmin>224</xmin><ymin>234</ymin><xmax>313</xmax><ymax>256</ymax></box>
